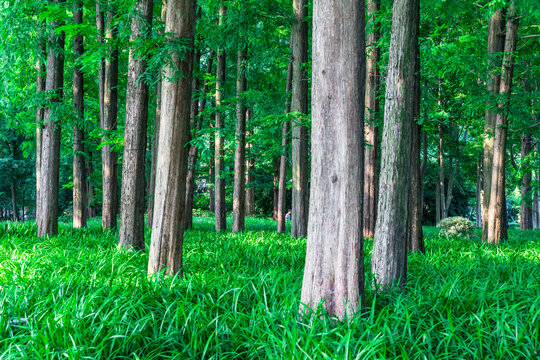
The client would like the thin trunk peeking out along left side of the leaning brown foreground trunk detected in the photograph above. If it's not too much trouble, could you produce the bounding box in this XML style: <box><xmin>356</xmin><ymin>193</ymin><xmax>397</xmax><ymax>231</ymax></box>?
<box><xmin>147</xmin><ymin>1</ymin><xmax>167</xmax><ymax>227</ymax></box>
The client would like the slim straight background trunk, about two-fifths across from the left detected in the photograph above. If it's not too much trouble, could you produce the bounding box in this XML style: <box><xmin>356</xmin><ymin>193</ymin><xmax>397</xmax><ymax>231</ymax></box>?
<box><xmin>214</xmin><ymin>2</ymin><xmax>227</xmax><ymax>231</ymax></box>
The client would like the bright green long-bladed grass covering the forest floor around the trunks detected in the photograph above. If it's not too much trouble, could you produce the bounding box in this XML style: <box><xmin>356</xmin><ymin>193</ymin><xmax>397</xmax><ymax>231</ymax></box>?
<box><xmin>0</xmin><ymin>218</ymin><xmax>540</xmax><ymax>359</ymax></box>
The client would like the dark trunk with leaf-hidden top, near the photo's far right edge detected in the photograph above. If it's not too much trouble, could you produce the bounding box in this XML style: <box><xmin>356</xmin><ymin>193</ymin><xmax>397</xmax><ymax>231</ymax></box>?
<box><xmin>519</xmin><ymin>134</ymin><xmax>533</xmax><ymax>230</ymax></box>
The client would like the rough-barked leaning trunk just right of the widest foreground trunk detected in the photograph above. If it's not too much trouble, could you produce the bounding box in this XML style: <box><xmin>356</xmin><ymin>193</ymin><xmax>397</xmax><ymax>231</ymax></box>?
<box><xmin>371</xmin><ymin>0</ymin><xmax>419</xmax><ymax>290</ymax></box>
